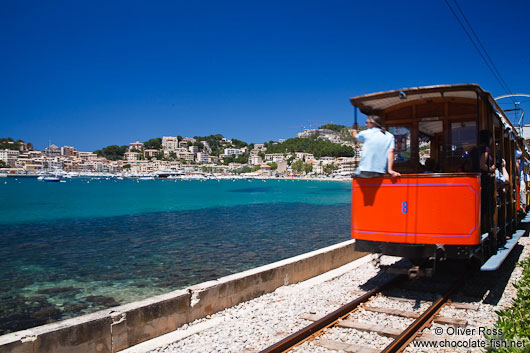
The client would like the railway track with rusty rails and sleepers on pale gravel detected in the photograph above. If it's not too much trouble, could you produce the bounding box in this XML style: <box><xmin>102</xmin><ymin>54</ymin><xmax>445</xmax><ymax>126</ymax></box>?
<box><xmin>260</xmin><ymin>272</ymin><xmax>471</xmax><ymax>353</ymax></box>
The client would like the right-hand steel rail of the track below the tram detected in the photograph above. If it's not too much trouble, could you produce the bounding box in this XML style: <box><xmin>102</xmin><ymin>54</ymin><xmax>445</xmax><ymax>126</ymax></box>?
<box><xmin>381</xmin><ymin>271</ymin><xmax>471</xmax><ymax>353</ymax></box>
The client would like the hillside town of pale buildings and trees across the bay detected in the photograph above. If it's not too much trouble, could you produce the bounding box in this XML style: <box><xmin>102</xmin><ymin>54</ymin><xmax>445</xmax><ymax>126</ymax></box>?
<box><xmin>0</xmin><ymin>125</ymin><xmax>360</xmax><ymax>177</ymax></box>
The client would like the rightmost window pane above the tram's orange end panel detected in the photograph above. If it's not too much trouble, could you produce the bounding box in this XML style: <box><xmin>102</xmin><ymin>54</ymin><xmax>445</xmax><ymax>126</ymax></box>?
<box><xmin>447</xmin><ymin>121</ymin><xmax>477</xmax><ymax>172</ymax></box>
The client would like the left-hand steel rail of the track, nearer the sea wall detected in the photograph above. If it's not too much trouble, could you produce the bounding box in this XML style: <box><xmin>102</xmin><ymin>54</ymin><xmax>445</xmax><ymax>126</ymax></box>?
<box><xmin>260</xmin><ymin>276</ymin><xmax>404</xmax><ymax>353</ymax></box>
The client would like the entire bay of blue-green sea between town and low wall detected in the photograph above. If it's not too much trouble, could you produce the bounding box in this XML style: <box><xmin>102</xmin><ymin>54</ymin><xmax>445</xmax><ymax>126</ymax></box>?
<box><xmin>0</xmin><ymin>178</ymin><xmax>351</xmax><ymax>334</ymax></box>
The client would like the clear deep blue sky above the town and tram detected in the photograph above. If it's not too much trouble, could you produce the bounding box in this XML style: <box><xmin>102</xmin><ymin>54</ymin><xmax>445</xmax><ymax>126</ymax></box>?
<box><xmin>0</xmin><ymin>0</ymin><xmax>530</xmax><ymax>151</ymax></box>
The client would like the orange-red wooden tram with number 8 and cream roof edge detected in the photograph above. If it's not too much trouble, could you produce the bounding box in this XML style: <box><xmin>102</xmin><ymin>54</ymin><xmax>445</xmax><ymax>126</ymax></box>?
<box><xmin>351</xmin><ymin>84</ymin><xmax>529</xmax><ymax>263</ymax></box>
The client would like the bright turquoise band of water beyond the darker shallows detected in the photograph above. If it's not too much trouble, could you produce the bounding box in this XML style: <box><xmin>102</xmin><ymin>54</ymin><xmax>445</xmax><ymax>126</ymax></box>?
<box><xmin>0</xmin><ymin>178</ymin><xmax>350</xmax><ymax>224</ymax></box>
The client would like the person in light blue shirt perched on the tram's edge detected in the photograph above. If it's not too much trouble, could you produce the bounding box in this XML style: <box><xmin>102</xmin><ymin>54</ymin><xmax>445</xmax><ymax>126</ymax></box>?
<box><xmin>352</xmin><ymin>115</ymin><xmax>401</xmax><ymax>178</ymax></box>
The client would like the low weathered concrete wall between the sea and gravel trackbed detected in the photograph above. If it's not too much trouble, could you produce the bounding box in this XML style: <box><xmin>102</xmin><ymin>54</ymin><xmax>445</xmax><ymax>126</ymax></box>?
<box><xmin>0</xmin><ymin>240</ymin><xmax>364</xmax><ymax>353</ymax></box>
